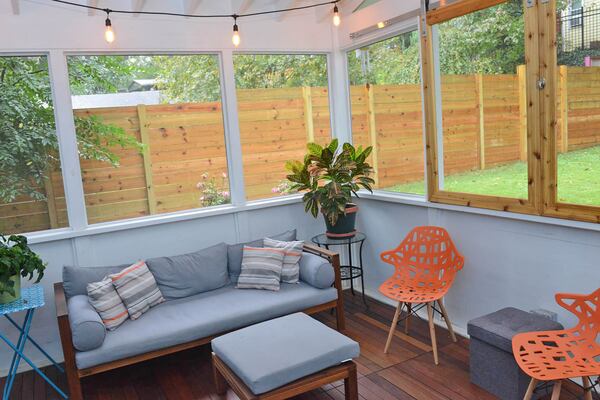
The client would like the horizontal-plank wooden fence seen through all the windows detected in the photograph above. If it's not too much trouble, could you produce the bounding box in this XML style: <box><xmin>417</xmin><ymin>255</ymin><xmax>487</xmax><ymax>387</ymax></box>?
<box><xmin>0</xmin><ymin>67</ymin><xmax>600</xmax><ymax>232</ymax></box>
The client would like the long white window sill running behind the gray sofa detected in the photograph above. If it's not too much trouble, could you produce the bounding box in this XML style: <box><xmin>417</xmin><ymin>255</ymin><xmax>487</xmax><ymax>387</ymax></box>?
<box><xmin>24</xmin><ymin>195</ymin><xmax>302</xmax><ymax>244</ymax></box>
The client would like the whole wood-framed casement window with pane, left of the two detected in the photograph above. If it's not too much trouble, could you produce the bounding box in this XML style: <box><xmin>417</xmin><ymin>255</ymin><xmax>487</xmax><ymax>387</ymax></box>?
<box><xmin>421</xmin><ymin>0</ymin><xmax>542</xmax><ymax>214</ymax></box>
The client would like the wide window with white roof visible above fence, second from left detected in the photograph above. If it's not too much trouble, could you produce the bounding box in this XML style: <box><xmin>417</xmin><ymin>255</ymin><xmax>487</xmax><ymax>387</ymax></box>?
<box><xmin>68</xmin><ymin>55</ymin><xmax>230</xmax><ymax>223</ymax></box>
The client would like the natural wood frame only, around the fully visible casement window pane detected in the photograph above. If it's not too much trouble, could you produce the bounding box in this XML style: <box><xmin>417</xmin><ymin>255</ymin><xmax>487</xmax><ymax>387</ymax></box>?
<box><xmin>421</xmin><ymin>0</ymin><xmax>542</xmax><ymax>215</ymax></box>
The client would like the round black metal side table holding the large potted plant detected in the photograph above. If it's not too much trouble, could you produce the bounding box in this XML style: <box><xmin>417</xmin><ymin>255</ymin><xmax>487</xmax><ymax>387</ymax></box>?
<box><xmin>311</xmin><ymin>232</ymin><xmax>368</xmax><ymax>307</ymax></box>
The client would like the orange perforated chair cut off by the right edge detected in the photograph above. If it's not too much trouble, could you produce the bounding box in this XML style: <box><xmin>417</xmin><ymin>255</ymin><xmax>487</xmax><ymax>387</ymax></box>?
<box><xmin>512</xmin><ymin>289</ymin><xmax>600</xmax><ymax>400</ymax></box>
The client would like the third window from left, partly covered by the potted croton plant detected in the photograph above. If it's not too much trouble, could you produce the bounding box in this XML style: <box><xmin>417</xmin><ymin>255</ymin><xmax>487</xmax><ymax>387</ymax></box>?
<box><xmin>234</xmin><ymin>54</ymin><xmax>331</xmax><ymax>200</ymax></box>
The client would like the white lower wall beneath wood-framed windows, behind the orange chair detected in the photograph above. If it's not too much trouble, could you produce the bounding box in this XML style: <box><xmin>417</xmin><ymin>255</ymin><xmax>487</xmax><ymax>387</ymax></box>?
<box><xmin>358</xmin><ymin>199</ymin><xmax>600</xmax><ymax>333</ymax></box>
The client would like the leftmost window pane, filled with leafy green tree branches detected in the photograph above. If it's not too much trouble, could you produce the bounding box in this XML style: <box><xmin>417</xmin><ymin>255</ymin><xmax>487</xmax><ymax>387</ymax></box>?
<box><xmin>0</xmin><ymin>56</ymin><xmax>69</xmax><ymax>234</ymax></box>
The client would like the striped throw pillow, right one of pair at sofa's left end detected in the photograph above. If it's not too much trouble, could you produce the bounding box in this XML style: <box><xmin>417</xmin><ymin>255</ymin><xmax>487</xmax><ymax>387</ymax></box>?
<box><xmin>108</xmin><ymin>261</ymin><xmax>165</xmax><ymax>319</ymax></box>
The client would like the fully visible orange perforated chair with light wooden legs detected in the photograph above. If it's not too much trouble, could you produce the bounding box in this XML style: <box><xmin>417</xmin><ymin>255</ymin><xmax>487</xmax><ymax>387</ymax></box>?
<box><xmin>379</xmin><ymin>226</ymin><xmax>464</xmax><ymax>365</ymax></box>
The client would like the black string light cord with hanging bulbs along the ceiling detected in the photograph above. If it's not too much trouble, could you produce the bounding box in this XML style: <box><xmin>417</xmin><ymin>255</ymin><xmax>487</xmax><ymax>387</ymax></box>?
<box><xmin>49</xmin><ymin>0</ymin><xmax>340</xmax><ymax>47</ymax></box>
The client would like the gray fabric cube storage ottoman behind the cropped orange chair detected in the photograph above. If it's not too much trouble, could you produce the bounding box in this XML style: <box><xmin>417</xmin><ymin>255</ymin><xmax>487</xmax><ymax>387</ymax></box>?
<box><xmin>468</xmin><ymin>308</ymin><xmax>563</xmax><ymax>400</ymax></box>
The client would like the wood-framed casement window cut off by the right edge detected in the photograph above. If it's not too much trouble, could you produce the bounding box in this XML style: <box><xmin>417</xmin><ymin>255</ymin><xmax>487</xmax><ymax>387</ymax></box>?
<box><xmin>539</xmin><ymin>0</ymin><xmax>600</xmax><ymax>222</ymax></box>
